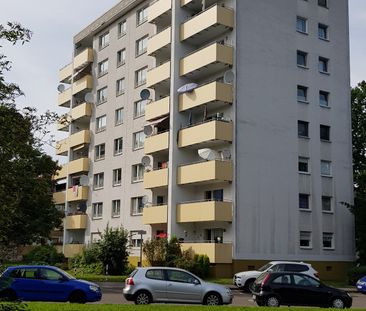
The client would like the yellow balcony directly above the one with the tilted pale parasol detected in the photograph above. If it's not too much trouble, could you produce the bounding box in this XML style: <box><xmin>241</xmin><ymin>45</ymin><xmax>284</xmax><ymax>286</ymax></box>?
<box><xmin>180</xmin><ymin>43</ymin><xmax>234</xmax><ymax>79</ymax></box>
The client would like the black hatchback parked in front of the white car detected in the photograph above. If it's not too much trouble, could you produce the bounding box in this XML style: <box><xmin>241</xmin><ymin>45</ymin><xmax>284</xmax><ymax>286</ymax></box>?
<box><xmin>252</xmin><ymin>272</ymin><xmax>352</xmax><ymax>309</ymax></box>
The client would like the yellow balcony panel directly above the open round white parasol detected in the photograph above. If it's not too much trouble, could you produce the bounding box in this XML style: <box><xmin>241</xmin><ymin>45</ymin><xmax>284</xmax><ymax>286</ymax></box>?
<box><xmin>178</xmin><ymin>120</ymin><xmax>233</xmax><ymax>148</ymax></box>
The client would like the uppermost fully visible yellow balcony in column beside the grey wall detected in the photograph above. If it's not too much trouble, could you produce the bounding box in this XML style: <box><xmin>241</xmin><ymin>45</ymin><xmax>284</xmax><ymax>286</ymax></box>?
<box><xmin>180</xmin><ymin>5</ymin><xmax>234</xmax><ymax>44</ymax></box>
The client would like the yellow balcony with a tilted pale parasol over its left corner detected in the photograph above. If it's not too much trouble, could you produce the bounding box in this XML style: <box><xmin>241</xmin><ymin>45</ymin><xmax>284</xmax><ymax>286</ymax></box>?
<box><xmin>179</xmin><ymin>82</ymin><xmax>233</xmax><ymax>112</ymax></box>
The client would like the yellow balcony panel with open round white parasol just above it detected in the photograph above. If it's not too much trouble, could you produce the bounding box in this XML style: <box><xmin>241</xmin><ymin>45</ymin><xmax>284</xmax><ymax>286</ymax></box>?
<box><xmin>177</xmin><ymin>160</ymin><xmax>233</xmax><ymax>185</ymax></box>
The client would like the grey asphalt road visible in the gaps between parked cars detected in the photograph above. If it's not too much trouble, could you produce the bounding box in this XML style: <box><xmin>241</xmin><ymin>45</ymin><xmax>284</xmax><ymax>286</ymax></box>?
<box><xmin>98</xmin><ymin>282</ymin><xmax>366</xmax><ymax>308</ymax></box>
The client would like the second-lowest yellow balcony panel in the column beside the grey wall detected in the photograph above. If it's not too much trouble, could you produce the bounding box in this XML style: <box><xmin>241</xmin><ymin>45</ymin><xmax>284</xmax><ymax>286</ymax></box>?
<box><xmin>177</xmin><ymin>201</ymin><xmax>233</xmax><ymax>223</ymax></box>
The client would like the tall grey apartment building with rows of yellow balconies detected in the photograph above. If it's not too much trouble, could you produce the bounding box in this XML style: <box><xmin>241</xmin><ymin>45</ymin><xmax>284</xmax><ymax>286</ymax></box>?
<box><xmin>54</xmin><ymin>0</ymin><xmax>355</xmax><ymax>279</ymax></box>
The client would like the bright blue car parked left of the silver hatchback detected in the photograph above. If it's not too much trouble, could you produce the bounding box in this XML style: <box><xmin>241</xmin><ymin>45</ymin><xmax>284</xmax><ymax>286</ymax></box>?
<box><xmin>0</xmin><ymin>266</ymin><xmax>102</xmax><ymax>303</ymax></box>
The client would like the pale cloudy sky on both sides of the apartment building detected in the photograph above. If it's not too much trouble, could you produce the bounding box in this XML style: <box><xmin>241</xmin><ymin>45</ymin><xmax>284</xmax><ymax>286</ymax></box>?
<box><xmin>0</xmin><ymin>0</ymin><xmax>366</xmax><ymax>156</ymax></box>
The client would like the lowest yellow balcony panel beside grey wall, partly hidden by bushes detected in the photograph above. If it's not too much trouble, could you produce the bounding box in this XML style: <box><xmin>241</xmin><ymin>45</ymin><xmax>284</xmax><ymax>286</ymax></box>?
<box><xmin>181</xmin><ymin>243</ymin><xmax>233</xmax><ymax>263</ymax></box>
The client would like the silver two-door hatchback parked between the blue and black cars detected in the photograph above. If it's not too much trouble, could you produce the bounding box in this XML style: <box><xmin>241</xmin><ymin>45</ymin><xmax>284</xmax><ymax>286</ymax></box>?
<box><xmin>123</xmin><ymin>267</ymin><xmax>233</xmax><ymax>305</ymax></box>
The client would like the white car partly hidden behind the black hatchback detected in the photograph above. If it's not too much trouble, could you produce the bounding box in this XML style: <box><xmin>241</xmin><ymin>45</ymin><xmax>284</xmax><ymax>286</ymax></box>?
<box><xmin>233</xmin><ymin>261</ymin><xmax>319</xmax><ymax>292</ymax></box>
